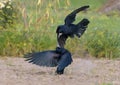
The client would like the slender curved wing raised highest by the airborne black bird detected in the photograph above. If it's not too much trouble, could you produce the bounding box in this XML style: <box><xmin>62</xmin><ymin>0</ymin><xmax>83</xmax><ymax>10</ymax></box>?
<box><xmin>65</xmin><ymin>6</ymin><xmax>89</xmax><ymax>25</ymax></box>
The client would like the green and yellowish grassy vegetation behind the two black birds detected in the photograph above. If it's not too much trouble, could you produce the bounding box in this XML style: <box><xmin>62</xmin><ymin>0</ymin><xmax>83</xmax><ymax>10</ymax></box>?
<box><xmin>0</xmin><ymin>0</ymin><xmax>120</xmax><ymax>58</ymax></box>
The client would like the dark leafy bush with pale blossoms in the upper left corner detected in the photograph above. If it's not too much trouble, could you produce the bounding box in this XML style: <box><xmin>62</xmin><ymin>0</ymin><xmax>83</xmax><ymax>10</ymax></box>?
<box><xmin>0</xmin><ymin>0</ymin><xmax>19</xmax><ymax>30</ymax></box>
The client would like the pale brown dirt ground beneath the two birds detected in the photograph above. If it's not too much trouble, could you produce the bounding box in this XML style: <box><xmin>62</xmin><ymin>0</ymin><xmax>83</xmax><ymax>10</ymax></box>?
<box><xmin>0</xmin><ymin>58</ymin><xmax>120</xmax><ymax>85</ymax></box>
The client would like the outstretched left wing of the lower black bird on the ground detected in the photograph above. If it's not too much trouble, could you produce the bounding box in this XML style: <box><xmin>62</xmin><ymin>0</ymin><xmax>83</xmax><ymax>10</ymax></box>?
<box><xmin>24</xmin><ymin>50</ymin><xmax>59</xmax><ymax>67</ymax></box>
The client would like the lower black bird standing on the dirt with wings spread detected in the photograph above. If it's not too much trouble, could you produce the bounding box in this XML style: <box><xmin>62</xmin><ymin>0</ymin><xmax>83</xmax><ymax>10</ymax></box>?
<box><xmin>25</xmin><ymin>47</ymin><xmax>72</xmax><ymax>74</ymax></box>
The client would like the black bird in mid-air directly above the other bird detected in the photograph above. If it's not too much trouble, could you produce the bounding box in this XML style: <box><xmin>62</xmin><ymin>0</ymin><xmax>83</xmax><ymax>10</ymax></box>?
<box><xmin>56</xmin><ymin>6</ymin><xmax>89</xmax><ymax>48</ymax></box>
